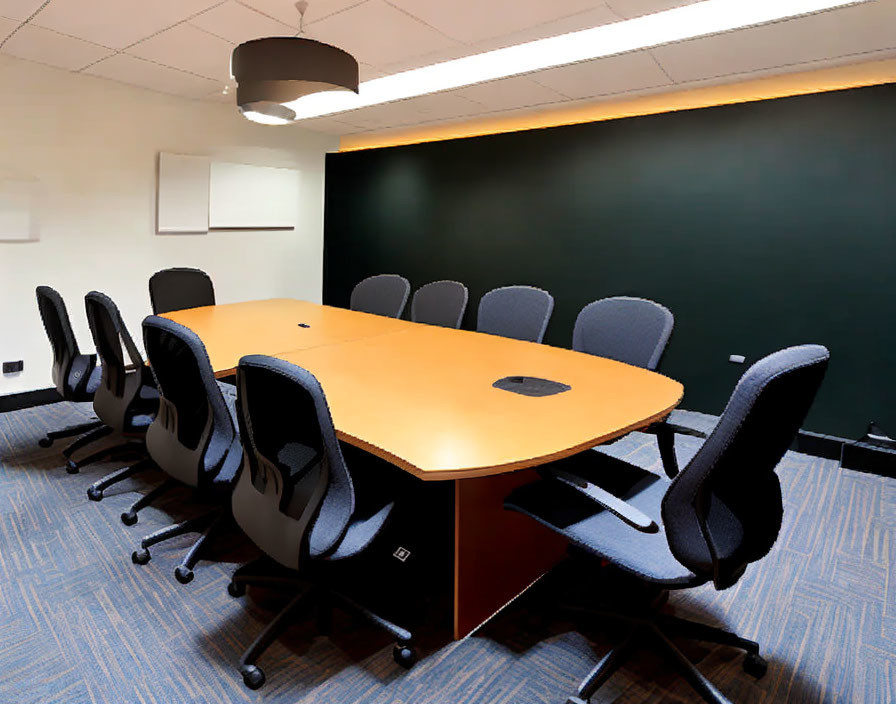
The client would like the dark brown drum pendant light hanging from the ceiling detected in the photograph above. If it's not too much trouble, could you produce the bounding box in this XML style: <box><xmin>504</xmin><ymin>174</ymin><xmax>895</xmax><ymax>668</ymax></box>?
<box><xmin>230</xmin><ymin>0</ymin><xmax>358</xmax><ymax>125</ymax></box>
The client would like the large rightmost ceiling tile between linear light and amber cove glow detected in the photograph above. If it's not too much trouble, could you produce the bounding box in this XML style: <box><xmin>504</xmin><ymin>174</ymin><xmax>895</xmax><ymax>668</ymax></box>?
<box><xmin>651</xmin><ymin>2</ymin><xmax>896</xmax><ymax>82</ymax></box>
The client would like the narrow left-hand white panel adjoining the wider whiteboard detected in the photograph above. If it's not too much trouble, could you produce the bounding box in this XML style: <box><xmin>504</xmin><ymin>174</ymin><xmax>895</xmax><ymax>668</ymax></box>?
<box><xmin>158</xmin><ymin>152</ymin><xmax>210</xmax><ymax>233</ymax></box>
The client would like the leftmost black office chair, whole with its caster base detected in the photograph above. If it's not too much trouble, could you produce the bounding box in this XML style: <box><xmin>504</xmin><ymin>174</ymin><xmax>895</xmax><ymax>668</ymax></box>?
<box><xmin>36</xmin><ymin>286</ymin><xmax>104</xmax><ymax>457</ymax></box>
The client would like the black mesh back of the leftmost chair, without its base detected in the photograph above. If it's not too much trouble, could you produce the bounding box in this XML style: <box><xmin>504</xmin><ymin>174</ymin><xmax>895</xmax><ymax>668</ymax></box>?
<box><xmin>36</xmin><ymin>286</ymin><xmax>96</xmax><ymax>401</ymax></box>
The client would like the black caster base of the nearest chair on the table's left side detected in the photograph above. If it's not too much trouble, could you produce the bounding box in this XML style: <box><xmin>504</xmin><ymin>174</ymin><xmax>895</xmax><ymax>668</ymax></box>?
<box><xmin>227</xmin><ymin>557</ymin><xmax>417</xmax><ymax>689</ymax></box>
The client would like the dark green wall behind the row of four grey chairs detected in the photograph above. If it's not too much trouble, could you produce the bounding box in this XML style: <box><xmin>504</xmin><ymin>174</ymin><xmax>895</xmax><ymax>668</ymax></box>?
<box><xmin>324</xmin><ymin>85</ymin><xmax>896</xmax><ymax>437</ymax></box>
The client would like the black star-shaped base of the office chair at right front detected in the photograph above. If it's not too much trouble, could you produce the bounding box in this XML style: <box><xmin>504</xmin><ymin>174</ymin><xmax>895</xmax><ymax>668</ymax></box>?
<box><xmin>561</xmin><ymin>576</ymin><xmax>768</xmax><ymax>704</ymax></box>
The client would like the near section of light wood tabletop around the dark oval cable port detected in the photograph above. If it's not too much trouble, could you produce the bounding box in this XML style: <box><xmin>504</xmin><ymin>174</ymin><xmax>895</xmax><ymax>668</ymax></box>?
<box><xmin>276</xmin><ymin>324</ymin><xmax>684</xmax><ymax>480</ymax></box>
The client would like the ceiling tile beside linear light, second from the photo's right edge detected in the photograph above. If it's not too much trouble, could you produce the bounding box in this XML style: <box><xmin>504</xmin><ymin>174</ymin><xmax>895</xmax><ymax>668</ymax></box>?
<box><xmin>528</xmin><ymin>51</ymin><xmax>672</xmax><ymax>99</ymax></box>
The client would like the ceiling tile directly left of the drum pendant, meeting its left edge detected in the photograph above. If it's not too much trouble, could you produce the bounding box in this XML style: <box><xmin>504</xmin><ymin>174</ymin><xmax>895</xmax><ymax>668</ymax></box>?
<box><xmin>127</xmin><ymin>23</ymin><xmax>234</xmax><ymax>82</ymax></box>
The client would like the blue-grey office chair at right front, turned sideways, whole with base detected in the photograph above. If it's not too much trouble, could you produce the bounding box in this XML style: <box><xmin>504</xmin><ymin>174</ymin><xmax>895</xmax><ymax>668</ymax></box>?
<box><xmin>504</xmin><ymin>345</ymin><xmax>829</xmax><ymax>704</ymax></box>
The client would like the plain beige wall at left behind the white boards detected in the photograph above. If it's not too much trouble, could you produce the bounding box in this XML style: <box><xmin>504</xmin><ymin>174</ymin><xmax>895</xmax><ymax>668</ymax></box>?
<box><xmin>0</xmin><ymin>56</ymin><xmax>338</xmax><ymax>395</ymax></box>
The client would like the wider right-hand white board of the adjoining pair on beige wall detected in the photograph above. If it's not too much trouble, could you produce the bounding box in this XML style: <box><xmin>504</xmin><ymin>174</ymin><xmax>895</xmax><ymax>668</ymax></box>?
<box><xmin>208</xmin><ymin>162</ymin><xmax>300</xmax><ymax>230</ymax></box>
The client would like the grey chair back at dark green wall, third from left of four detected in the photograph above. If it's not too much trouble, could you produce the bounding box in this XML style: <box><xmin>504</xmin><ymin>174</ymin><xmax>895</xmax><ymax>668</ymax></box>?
<box><xmin>476</xmin><ymin>286</ymin><xmax>554</xmax><ymax>342</ymax></box>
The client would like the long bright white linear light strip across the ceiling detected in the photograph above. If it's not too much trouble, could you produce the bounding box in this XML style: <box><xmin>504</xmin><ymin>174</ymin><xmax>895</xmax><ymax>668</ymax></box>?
<box><xmin>284</xmin><ymin>0</ymin><xmax>871</xmax><ymax>119</ymax></box>
